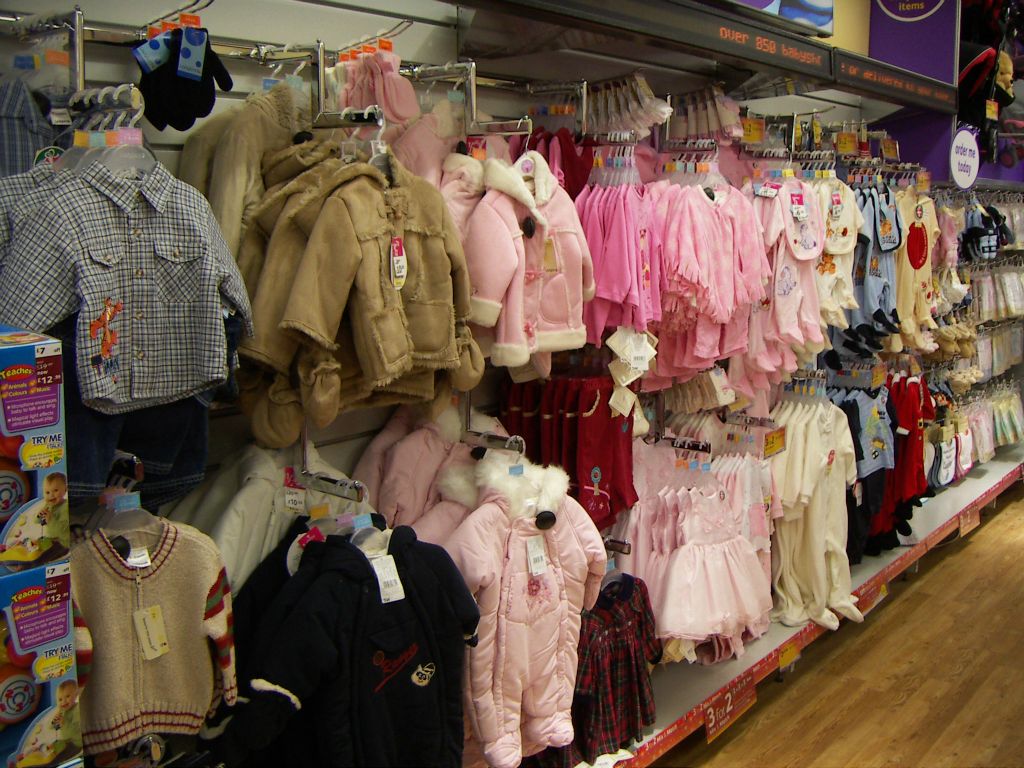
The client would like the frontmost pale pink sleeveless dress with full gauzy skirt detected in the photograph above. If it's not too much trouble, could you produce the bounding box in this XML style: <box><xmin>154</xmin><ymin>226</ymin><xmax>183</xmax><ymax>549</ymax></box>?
<box><xmin>656</xmin><ymin>488</ymin><xmax>772</xmax><ymax>655</ymax></box>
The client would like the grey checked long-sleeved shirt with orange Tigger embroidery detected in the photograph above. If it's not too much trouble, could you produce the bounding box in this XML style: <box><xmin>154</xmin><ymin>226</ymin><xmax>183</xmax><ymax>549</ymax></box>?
<box><xmin>0</xmin><ymin>162</ymin><xmax>252</xmax><ymax>414</ymax></box>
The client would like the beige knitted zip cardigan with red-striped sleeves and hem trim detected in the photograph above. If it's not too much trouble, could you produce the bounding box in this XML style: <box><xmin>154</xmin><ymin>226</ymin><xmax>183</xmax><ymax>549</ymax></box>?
<box><xmin>71</xmin><ymin>520</ymin><xmax>238</xmax><ymax>754</ymax></box>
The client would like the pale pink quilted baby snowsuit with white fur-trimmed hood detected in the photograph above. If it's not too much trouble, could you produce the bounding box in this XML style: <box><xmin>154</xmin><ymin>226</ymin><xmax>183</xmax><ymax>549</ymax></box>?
<box><xmin>446</xmin><ymin>451</ymin><xmax>606</xmax><ymax>768</ymax></box>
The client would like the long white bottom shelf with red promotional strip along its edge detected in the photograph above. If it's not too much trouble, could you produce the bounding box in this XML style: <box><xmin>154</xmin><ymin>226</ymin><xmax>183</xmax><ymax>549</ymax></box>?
<box><xmin>618</xmin><ymin>445</ymin><xmax>1024</xmax><ymax>768</ymax></box>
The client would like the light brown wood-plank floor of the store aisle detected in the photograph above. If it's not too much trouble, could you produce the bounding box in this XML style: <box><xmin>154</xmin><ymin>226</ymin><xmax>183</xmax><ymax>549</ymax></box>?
<box><xmin>656</xmin><ymin>486</ymin><xmax>1024</xmax><ymax>768</ymax></box>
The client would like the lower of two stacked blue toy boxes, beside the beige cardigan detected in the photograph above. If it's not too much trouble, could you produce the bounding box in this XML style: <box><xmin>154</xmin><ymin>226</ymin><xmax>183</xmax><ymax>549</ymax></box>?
<box><xmin>0</xmin><ymin>560</ymin><xmax>82</xmax><ymax>768</ymax></box>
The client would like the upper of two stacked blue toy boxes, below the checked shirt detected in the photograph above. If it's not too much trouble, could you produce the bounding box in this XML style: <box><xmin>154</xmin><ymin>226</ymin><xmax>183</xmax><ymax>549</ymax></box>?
<box><xmin>0</xmin><ymin>326</ymin><xmax>71</xmax><ymax>575</ymax></box>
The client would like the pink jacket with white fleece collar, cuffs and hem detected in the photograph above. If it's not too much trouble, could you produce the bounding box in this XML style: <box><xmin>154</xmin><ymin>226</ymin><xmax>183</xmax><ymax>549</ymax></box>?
<box><xmin>465</xmin><ymin>152</ymin><xmax>594</xmax><ymax>367</ymax></box>
